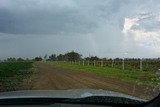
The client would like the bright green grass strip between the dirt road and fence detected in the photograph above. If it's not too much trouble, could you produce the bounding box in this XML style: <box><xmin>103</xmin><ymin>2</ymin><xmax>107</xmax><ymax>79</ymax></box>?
<box><xmin>45</xmin><ymin>61</ymin><xmax>160</xmax><ymax>88</ymax></box>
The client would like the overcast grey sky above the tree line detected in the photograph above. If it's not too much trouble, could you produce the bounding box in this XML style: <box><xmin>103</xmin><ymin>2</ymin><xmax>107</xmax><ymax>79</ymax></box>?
<box><xmin>0</xmin><ymin>0</ymin><xmax>160</xmax><ymax>59</ymax></box>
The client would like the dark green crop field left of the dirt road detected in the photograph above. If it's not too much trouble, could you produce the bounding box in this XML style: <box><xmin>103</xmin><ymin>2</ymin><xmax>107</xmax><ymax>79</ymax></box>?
<box><xmin>0</xmin><ymin>61</ymin><xmax>33</xmax><ymax>91</ymax></box>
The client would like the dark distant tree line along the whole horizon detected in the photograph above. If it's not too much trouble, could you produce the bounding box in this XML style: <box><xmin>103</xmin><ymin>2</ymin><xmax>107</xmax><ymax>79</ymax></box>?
<box><xmin>1</xmin><ymin>51</ymin><xmax>160</xmax><ymax>61</ymax></box>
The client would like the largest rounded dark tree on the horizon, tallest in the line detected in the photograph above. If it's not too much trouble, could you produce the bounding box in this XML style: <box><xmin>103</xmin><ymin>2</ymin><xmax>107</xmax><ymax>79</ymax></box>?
<box><xmin>65</xmin><ymin>51</ymin><xmax>82</xmax><ymax>61</ymax></box>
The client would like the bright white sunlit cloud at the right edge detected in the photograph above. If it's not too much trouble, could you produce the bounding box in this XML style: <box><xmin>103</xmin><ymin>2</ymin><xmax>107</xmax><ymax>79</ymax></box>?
<box><xmin>122</xmin><ymin>13</ymin><xmax>160</xmax><ymax>51</ymax></box>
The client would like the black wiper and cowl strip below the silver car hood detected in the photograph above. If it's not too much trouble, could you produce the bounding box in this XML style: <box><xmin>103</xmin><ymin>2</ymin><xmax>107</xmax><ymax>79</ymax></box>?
<box><xmin>0</xmin><ymin>96</ymin><xmax>145</xmax><ymax>105</ymax></box>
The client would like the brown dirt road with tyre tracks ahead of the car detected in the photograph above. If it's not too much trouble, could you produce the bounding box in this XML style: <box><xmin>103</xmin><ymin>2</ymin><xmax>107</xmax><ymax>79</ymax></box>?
<box><xmin>26</xmin><ymin>62</ymin><xmax>157</xmax><ymax>98</ymax></box>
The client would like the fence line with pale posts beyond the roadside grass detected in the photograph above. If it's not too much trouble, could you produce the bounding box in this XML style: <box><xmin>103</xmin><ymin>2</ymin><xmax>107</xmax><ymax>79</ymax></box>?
<box><xmin>67</xmin><ymin>59</ymin><xmax>160</xmax><ymax>71</ymax></box>
